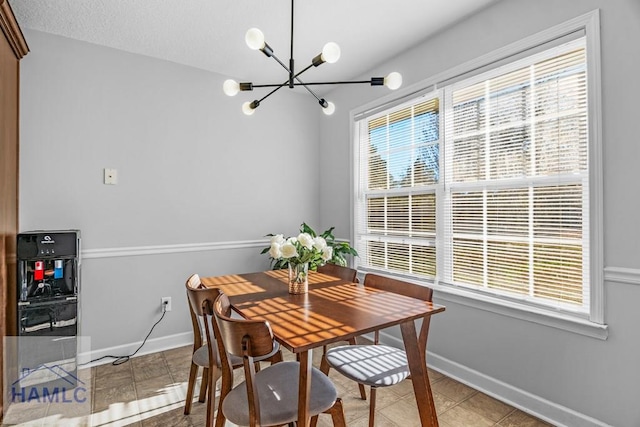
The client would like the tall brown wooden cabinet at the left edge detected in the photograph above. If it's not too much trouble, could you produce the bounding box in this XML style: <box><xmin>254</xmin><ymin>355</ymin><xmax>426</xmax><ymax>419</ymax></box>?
<box><xmin>0</xmin><ymin>0</ymin><xmax>29</xmax><ymax>419</ymax></box>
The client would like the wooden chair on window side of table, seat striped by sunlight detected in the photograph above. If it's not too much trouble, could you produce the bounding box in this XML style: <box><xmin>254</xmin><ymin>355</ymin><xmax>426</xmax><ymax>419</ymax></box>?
<box><xmin>320</xmin><ymin>274</ymin><xmax>433</xmax><ymax>427</ymax></box>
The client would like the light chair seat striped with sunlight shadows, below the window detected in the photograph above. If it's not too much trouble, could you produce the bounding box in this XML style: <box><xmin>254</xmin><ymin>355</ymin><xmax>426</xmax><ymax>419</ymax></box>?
<box><xmin>325</xmin><ymin>345</ymin><xmax>409</xmax><ymax>387</ymax></box>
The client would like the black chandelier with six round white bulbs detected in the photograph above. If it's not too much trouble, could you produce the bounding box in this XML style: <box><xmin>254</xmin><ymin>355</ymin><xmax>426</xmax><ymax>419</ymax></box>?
<box><xmin>222</xmin><ymin>0</ymin><xmax>402</xmax><ymax>116</ymax></box>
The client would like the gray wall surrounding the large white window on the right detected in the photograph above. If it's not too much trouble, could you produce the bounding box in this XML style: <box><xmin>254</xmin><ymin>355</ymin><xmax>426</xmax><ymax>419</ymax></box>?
<box><xmin>320</xmin><ymin>0</ymin><xmax>640</xmax><ymax>427</ymax></box>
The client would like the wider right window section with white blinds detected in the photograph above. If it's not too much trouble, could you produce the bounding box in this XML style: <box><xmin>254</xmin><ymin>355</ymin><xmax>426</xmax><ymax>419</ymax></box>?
<box><xmin>443</xmin><ymin>39</ymin><xmax>589</xmax><ymax>313</ymax></box>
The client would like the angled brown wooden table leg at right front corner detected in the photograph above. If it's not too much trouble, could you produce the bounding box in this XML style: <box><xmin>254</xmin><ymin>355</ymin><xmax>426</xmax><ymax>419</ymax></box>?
<box><xmin>400</xmin><ymin>321</ymin><xmax>438</xmax><ymax>427</ymax></box>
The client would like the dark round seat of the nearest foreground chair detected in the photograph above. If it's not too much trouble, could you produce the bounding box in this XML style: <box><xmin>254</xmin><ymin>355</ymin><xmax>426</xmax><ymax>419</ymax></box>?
<box><xmin>222</xmin><ymin>362</ymin><xmax>338</xmax><ymax>426</ymax></box>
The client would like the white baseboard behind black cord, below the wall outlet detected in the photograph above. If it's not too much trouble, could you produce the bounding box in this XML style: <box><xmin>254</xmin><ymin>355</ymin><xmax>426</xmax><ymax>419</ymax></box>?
<box><xmin>78</xmin><ymin>332</ymin><xmax>193</xmax><ymax>368</ymax></box>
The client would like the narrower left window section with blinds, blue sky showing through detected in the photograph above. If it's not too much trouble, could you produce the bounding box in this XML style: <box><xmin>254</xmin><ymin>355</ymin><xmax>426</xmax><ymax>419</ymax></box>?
<box><xmin>356</xmin><ymin>97</ymin><xmax>440</xmax><ymax>278</ymax></box>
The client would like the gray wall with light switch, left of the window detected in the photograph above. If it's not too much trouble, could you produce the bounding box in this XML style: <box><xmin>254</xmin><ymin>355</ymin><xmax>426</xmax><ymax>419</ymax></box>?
<box><xmin>20</xmin><ymin>31</ymin><xmax>322</xmax><ymax>355</ymax></box>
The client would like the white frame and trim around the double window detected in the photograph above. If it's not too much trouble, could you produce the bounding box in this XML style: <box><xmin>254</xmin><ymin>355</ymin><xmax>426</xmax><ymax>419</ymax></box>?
<box><xmin>350</xmin><ymin>9</ymin><xmax>608</xmax><ymax>339</ymax></box>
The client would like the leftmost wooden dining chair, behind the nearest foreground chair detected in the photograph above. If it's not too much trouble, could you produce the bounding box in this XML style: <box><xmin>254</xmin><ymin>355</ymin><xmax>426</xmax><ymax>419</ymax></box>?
<box><xmin>184</xmin><ymin>274</ymin><xmax>282</xmax><ymax>426</ymax></box>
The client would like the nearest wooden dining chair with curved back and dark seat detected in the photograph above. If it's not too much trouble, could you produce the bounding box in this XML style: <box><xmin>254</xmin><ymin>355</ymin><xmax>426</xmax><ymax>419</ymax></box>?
<box><xmin>205</xmin><ymin>293</ymin><xmax>346</xmax><ymax>427</ymax></box>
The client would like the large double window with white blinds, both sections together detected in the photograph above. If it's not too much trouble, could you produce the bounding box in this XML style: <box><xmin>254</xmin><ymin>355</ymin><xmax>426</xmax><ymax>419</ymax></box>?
<box><xmin>354</xmin><ymin>11</ymin><xmax>602</xmax><ymax>332</ymax></box>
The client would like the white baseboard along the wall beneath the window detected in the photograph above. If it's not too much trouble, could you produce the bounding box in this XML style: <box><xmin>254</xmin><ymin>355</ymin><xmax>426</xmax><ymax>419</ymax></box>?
<box><xmin>380</xmin><ymin>332</ymin><xmax>611</xmax><ymax>427</ymax></box>
